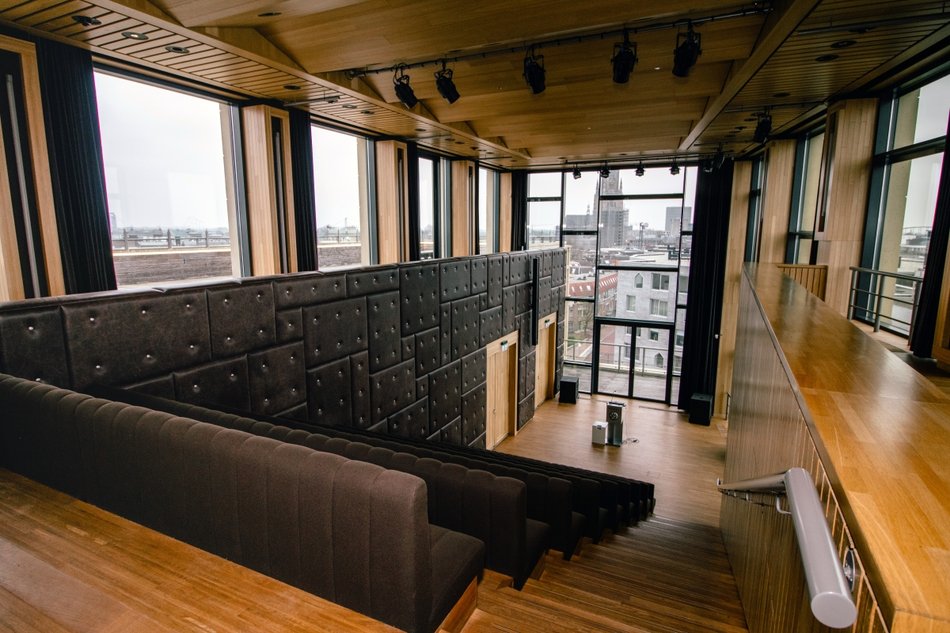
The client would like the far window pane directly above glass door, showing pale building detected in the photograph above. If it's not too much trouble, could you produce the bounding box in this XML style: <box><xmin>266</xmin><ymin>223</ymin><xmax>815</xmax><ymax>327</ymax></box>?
<box><xmin>597</xmin><ymin>268</ymin><xmax>680</xmax><ymax>322</ymax></box>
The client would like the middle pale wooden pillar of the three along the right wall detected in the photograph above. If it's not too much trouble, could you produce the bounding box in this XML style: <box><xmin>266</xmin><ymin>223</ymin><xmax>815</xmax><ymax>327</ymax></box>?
<box><xmin>760</xmin><ymin>140</ymin><xmax>795</xmax><ymax>264</ymax></box>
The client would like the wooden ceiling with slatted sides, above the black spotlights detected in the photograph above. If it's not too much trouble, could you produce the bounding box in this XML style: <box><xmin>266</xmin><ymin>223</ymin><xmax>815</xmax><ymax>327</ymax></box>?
<box><xmin>0</xmin><ymin>0</ymin><xmax>950</xmax><ymax>168</ymax></box>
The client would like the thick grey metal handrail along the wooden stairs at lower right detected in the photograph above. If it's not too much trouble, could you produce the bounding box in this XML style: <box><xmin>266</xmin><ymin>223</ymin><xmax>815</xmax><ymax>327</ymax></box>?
<box><xmin>717</xmin><ymin>468</ymin><xmax>858</xmax><ymax>628</ymax></box>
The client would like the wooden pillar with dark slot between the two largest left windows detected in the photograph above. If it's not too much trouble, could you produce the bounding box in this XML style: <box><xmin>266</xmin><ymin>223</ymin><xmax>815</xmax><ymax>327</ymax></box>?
<box><xmin>241</xmin><ymin>105</ymin><xmax>297</xmax><ymax>275</ymax></box>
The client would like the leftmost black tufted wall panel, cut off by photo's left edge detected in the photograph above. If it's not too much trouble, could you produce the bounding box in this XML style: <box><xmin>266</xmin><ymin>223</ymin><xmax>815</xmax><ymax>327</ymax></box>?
<box><xmin>0</xmin><ymin>308</ymin><xmax>71</xmax><ymax>387</ymax></box>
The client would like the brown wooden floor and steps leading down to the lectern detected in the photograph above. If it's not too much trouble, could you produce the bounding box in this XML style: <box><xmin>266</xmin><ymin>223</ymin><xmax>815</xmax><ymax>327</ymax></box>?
<box><xmin>463</xmin><ymin>396</ymin><xmax>747</xmax><ymax>633</ymax></box>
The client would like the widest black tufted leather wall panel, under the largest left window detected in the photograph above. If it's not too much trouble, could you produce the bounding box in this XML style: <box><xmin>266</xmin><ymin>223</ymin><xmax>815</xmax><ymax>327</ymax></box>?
<box><xmin>61</xmin><ymin>290</ymin><xmax>211</xmax><ymax>389</ymax></box>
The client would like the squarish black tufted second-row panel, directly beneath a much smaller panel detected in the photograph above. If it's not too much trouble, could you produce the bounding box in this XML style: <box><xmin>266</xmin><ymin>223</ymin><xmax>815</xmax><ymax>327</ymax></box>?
<box><xmin>247</xmin><ymin>341</ymin><xmax>307</xmax><ymax>415</ymax></box>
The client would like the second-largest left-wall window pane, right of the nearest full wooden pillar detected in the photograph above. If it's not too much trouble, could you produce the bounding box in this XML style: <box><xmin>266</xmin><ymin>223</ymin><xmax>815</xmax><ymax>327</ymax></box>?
<box><xmin>310</xmin><ymin>126</ymin><xmax>368</xmax><ymax>270</ymax></box>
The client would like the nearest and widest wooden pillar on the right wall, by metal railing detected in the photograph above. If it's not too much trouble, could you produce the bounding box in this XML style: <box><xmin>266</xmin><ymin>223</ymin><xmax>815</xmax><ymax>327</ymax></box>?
<box><xmin>815</xmin><ymin>99</ymin><xmax>877</xmax><ymax>315</ymax></box>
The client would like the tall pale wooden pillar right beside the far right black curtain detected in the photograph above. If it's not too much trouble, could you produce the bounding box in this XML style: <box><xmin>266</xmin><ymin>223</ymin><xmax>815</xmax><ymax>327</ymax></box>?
<box><xmin>715</xmin><ymin>161</ymin><xmax>752</xmax><ymax>417</ymax></box>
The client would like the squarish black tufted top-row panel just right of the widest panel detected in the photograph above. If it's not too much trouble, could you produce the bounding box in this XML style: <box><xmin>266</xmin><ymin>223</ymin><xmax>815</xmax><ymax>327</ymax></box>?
<box><xmin>208</xmin><ymin>283</ymin><xmax>277</xmax><ymax>359</ymax></box>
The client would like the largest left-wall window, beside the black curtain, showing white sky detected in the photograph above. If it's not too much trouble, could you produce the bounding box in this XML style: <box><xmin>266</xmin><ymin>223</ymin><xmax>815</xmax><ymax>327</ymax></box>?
<box><xmin>95</xmin><ymin>72</ymin><xmax>241</xmax><ymax>287</ymax></box>
